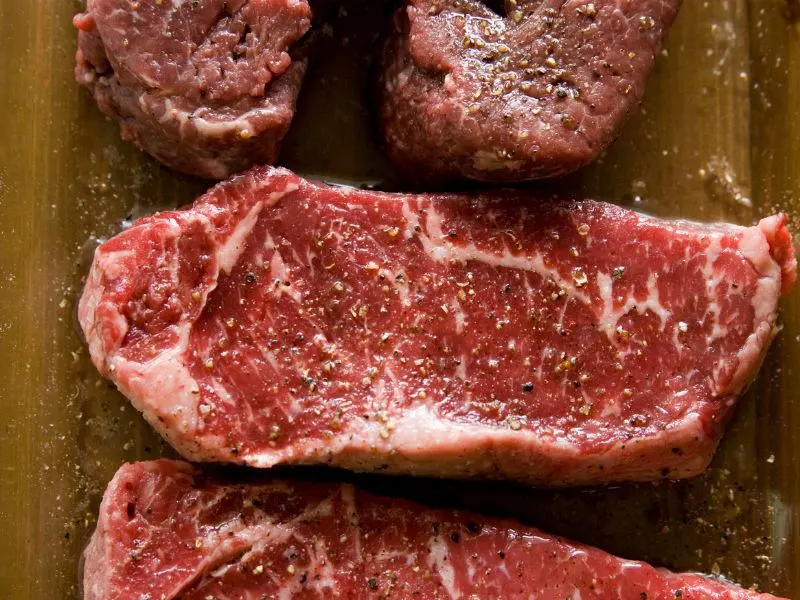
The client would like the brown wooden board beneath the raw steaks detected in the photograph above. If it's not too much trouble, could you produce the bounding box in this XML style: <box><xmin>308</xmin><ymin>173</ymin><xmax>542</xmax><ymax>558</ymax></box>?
<box><xmin>0</xmin><ymin>0</ymin><xmax>800</xmax><ymax>600</ymax></box>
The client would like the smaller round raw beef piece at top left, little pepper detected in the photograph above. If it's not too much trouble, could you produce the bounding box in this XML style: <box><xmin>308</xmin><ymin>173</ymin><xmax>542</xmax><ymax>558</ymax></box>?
<box><xmin>74</xmin><ymin>0</ymin><xmax>310</xmax><ymax>179</ymax></box>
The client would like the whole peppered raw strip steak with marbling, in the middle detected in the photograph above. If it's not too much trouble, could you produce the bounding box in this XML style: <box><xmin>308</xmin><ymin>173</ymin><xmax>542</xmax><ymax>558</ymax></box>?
<box><xmin>79</xmin><ymin>168</ymin><xmax>795</xmax><ymax>485</ymax></box>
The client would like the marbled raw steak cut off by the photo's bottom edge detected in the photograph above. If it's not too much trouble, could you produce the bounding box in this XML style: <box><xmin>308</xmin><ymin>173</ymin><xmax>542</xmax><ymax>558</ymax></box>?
<box><xmin>84</xmin><ymin>460</ymin><xmax>788</xmax><ymax>600</ymax></box>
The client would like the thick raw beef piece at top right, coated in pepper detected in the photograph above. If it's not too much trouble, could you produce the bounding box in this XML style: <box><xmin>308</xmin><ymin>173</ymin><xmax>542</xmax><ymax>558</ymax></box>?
<box><xmin>380</xmin><ymin>0</ymin><xmax>681</xmax><ymax>181</ymax></box>
